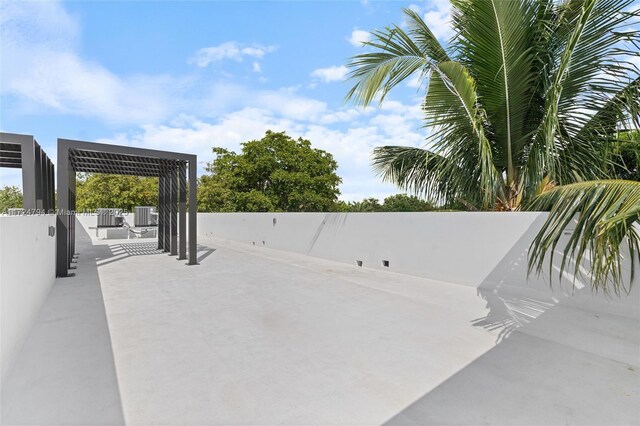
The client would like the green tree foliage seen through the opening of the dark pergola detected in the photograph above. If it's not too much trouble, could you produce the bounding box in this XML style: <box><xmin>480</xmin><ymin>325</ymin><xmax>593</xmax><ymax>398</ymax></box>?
<box><xmin>76</xmin><ymin>174</ymin><xmax>158</xmax><ymax>211</ymax></box>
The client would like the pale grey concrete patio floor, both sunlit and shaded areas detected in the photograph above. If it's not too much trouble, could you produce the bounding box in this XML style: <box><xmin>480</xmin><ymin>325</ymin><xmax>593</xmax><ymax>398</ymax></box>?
<box><xmin>2</xmin><ymin>221</ymin><xmax>640</xmax><ymax>425</ymax></box>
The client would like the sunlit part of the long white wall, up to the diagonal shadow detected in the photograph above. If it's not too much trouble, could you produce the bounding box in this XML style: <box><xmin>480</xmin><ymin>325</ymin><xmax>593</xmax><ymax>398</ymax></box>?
<box><xmin>198</xmin><ymin>212</ymin><xmax>544</xmax><ymax>286</ymax></box>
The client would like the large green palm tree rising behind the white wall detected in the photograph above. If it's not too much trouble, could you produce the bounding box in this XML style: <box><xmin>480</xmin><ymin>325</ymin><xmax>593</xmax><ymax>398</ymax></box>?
<box><xmin>347</xmin><ymin>0</ymin><xmax>640</xmax><ymax>293</ymax></box>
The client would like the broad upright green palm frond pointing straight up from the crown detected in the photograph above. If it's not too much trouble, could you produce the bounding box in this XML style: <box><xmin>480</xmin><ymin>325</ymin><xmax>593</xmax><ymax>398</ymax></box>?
<box><xmin>454</xmin><ymin>0</ymin><xmax>541</xmax><ymax>187</ymax></box>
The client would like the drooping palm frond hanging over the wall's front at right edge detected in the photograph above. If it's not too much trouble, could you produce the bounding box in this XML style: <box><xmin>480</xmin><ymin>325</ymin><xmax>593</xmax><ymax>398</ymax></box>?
<box><xmin>528</xmin><ymin>180</ymin><xmax>640</xmax><ymax>294</ymax></box>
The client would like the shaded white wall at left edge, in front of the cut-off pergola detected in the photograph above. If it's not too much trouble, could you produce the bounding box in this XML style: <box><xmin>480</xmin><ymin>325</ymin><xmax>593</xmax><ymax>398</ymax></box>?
<box><xmin>0</xmin><ymin>215</ymin><xmax>56</xmax><ymax>379</ymax></box>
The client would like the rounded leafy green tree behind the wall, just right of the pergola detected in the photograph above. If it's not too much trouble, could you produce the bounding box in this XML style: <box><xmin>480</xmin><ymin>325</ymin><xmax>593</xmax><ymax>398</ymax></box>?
<box><xmin>198</xmin><ymin>131</ymin><xmax>341</xmax><ymax>212</ymax></box>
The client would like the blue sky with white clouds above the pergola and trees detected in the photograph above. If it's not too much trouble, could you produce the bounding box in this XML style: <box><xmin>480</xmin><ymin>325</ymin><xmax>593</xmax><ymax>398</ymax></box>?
<box><xmin>0</xmin><ymin>0</ymin><xmax>450</xmax><ymax>200</ymax></box>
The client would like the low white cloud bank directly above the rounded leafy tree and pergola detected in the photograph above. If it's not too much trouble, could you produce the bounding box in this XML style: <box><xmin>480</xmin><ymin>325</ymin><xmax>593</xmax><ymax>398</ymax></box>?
<box><xmin>99</xmin><ymin>95</ymin><xmax>424</xmax><ymax>201</ymax></box>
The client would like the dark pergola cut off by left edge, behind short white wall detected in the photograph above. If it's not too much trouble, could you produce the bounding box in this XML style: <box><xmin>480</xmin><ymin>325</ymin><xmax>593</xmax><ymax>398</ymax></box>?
<box><xmin>0</xmin><ymin>133</ymin><xmax>55</xmax><ymax>213</ymax></box>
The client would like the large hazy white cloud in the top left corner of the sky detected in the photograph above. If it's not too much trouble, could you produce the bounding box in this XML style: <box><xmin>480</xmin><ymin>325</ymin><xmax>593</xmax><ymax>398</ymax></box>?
<box><xmin>0</xmin><ymin>2</ymin><xmax>184</xmax><ymax>123</ymax></box>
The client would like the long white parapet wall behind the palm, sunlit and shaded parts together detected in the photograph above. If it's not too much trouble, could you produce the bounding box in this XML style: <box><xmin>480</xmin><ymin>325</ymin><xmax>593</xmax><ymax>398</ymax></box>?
<box><xmin>198</xmin><ymin>212</ymin><xmax>640</xmax><ymax>318</ymax></box>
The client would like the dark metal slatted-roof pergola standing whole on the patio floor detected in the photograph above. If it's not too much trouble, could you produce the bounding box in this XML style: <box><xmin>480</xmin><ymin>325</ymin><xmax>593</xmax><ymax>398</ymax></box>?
<box><xmin>56</xmin><ymin>139</ymin><xmax>197</xmax><ymax>277</ymax></box>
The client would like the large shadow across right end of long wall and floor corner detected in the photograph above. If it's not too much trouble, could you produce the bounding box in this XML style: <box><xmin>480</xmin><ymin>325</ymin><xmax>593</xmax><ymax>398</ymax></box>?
<box><xmin>387</xmin><ymin>218</ymin><xmax>640</xmax><ymax>425</ymax></box>
